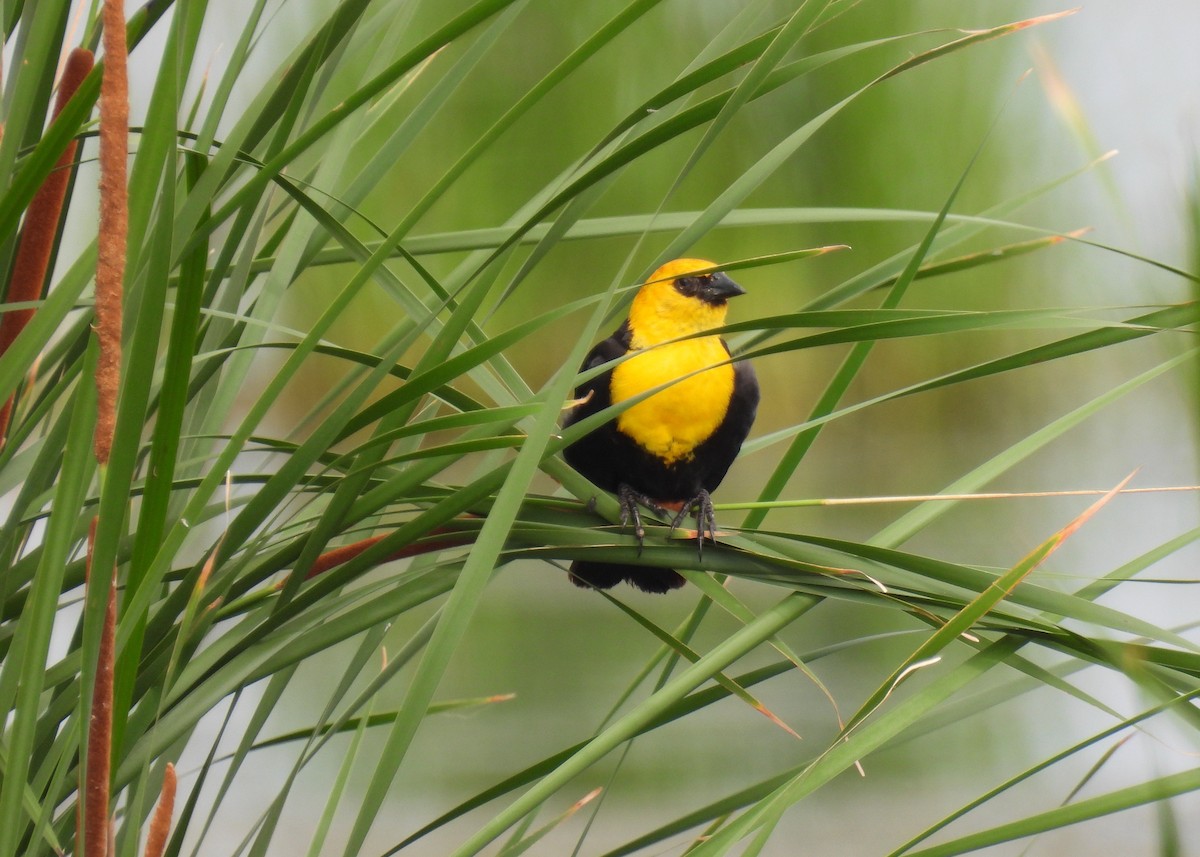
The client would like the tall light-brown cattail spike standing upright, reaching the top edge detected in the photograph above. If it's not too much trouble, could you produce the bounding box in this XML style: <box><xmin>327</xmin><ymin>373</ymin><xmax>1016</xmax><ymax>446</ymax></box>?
<box><xmin>94</xmin><ymin>0</ymin><xmax>130</xmax><ymax>465</ymax></box>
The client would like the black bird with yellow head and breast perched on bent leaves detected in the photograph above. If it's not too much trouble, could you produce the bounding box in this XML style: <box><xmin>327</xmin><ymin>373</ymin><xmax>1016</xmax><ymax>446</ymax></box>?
<box><xmin>563</xmin><ymin>259</ymin><xmax>758</xmax><ymax>592</ymax></box>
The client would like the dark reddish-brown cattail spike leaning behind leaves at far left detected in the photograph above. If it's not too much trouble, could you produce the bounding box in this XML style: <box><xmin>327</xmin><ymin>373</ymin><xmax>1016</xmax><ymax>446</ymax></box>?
<box><xmin>0</xmin><ymin>48</ymin><xmax>95</xmax><ymax>445</ymax></box>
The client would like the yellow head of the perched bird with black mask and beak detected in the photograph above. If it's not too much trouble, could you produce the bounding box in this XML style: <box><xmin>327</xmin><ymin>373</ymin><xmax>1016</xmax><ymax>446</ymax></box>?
<box><xmin>629</xmin><ymin>259</ymin><xmax>745</xmax><ymax>348</ymax></box>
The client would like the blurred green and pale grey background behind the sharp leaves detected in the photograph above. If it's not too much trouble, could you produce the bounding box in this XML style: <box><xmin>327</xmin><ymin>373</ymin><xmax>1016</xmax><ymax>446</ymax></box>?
<box><xmin>166</xmin><ymin>0</ymin><xmax>1200</xmax><ymax>856</ymax></box>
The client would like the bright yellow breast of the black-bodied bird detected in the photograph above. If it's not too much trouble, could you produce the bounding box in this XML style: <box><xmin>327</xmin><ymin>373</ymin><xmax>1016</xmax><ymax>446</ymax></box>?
<box><xmin>612</xmin><ymin>336</ymin><xmax>733</xmax><ymax>465</ymax></box>
